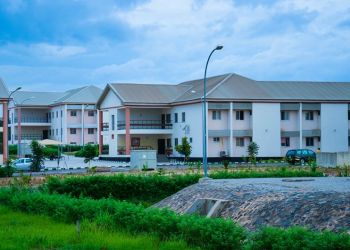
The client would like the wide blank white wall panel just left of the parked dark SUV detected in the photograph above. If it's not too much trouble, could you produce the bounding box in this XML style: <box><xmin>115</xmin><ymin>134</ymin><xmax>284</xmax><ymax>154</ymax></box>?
<box><xmin>252</xmin><ymin>103</ymin><xmax>281</xmax><ymax>157</ymax></box>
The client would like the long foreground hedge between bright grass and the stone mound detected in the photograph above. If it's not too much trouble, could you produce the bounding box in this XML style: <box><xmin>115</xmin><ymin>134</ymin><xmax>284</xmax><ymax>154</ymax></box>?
<box><xmin>0</xmin><ymin>188</ymin><xmax>350</xmax><ymax>250</ymax></box>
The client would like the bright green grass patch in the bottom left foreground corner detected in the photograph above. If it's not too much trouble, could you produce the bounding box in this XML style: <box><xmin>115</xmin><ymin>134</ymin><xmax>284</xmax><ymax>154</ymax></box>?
<box><xmin>0</xmin><ymin>206</ymin><xmax>190</xmax><ymax>250</ymax></box>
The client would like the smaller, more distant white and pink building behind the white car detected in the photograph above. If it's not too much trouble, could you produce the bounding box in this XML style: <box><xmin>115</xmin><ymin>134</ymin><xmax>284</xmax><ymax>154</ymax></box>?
<box><xmin>8</xmin><ymin>85</ymin><xmax>102</xmax><ymax>156</ymax></box>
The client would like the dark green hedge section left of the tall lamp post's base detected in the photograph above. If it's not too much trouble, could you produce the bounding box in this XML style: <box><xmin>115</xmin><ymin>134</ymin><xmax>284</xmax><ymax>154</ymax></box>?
<box><xmin>48</xmin><ymin>174</ymin><xmax>202</xmax><ymax>200</ymax></box>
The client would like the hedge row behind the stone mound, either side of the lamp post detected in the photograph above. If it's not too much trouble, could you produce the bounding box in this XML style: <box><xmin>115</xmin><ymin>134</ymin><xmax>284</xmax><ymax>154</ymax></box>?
<box><xmin>48</xmin><ymin>170</ymin><xmax>323</xmax><ymax>200</ymax></box>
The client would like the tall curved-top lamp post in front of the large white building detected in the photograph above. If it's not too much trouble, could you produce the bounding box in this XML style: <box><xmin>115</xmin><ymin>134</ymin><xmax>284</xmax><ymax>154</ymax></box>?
<box><xmin>203</xmin><ymin>45</ymin><xmax>224</xmax><ymax>178</ymax></box>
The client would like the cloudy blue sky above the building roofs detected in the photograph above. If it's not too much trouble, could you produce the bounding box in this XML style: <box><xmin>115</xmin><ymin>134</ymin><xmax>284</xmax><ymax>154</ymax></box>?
<box><xmin>0</xmin><ymin>0</ymin><xmax>350</xmax><ymax>91</ymax></box>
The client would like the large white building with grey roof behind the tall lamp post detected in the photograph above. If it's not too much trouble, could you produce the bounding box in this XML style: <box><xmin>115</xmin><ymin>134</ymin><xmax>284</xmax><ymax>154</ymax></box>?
<box><xmin>97</xmin><ymin>74</ymin><xmax>350</xmax><ymax>160</ymax></box>
